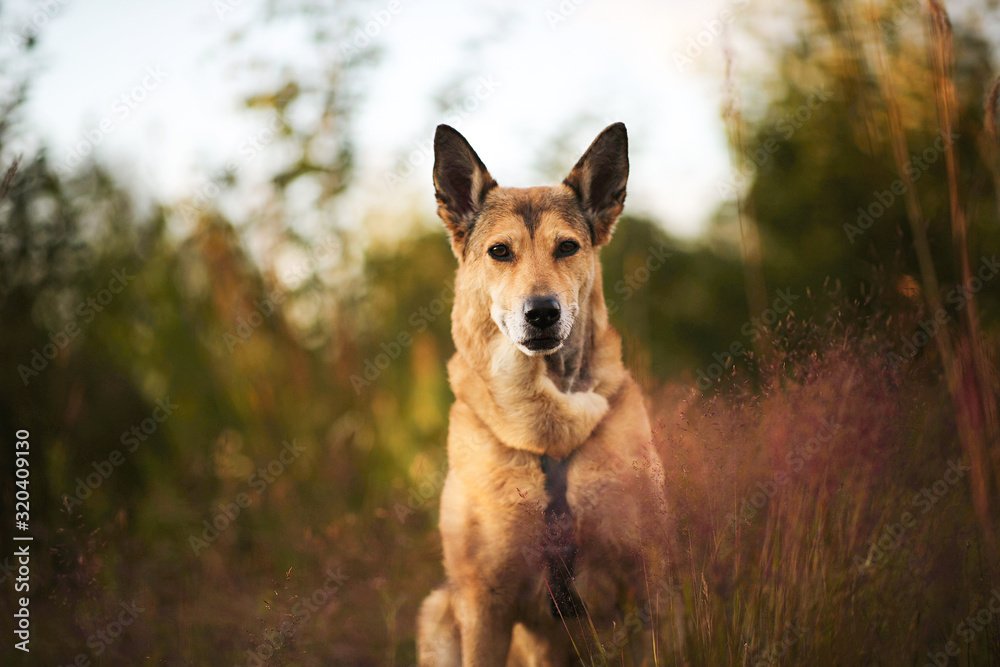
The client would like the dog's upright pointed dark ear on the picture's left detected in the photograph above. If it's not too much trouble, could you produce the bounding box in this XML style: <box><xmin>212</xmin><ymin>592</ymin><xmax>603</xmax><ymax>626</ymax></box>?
<box><xmin>434</xmin><ymin>125</ymin><xmax>497</xmax><ymax>256</ymax></box>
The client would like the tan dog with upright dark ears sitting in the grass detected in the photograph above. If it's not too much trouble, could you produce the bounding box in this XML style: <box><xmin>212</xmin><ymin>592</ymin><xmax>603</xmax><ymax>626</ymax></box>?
<box><xmin>417</xmin><ymin>123</ymin><xmax>665</xmax><ymax>667</ymax></box>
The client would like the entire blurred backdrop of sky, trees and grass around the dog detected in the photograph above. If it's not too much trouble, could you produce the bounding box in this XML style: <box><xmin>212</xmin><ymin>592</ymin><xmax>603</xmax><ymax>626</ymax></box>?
<box><xmin>0</xmin><ymin>0</ymin><xmax>1000</xmax><ymax>665</ymax></box>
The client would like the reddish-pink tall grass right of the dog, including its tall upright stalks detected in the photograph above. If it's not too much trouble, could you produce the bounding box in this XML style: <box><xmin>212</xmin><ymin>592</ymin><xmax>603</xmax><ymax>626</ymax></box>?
<box><xmin>624</xmin><ymin>0</ymin><xmax>1000</xmax><ymax>665</ymax></box>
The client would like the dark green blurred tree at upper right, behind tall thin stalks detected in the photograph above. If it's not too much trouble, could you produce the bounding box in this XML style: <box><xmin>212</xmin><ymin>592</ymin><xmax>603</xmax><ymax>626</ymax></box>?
<box><xmin>728</xmin><ymin>2</ymin><xmax>1000</xmax><ymax>312</ymax></box>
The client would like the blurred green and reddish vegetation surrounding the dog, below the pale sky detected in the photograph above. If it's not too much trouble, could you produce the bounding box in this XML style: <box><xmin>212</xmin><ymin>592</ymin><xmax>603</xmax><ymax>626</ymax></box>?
<box><xmin>0</xmin><ymin>0</ymin><xmax>1000</xmax><ymax>666</ymax></box>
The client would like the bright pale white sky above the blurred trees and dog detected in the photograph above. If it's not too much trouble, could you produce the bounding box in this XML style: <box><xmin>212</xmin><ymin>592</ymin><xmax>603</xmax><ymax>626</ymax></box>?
<box><xmin>0</xmin><ymin>0</ymin><xmax>763</xmax><ymax>236</ymax></box>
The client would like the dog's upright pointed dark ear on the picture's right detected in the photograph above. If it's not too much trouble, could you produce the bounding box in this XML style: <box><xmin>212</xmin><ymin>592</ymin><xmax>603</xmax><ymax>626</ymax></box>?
<box><xmin>563</xmin><ymin>123</ymin><xmax>628</xmax><ymax>246</ymax></box>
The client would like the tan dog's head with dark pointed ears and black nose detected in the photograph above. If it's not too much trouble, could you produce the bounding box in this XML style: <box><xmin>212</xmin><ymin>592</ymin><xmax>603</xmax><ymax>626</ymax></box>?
<box><xmin>434</xmin><ymin>123</ymin><xmax>628</xmax><ymax>355</ymax></box>
